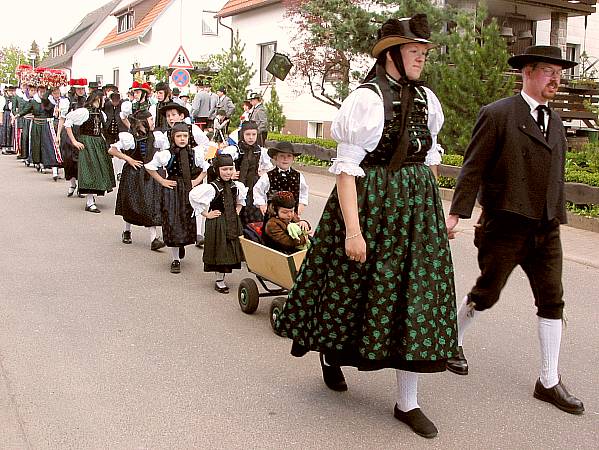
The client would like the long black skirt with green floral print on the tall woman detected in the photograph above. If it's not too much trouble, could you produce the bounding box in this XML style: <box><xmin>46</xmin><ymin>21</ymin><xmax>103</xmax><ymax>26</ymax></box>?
<box><xmin>275</xmin><ymin>164</ymin><xmax>457</xmax><ymax>372</ymax></box>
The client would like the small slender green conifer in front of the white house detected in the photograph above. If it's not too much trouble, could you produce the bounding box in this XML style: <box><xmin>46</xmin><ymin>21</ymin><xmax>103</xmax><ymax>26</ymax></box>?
<box><xmin>209</xmin><ymin>32</ymin><xmax>256</xmax><ymax>127</ymax></box>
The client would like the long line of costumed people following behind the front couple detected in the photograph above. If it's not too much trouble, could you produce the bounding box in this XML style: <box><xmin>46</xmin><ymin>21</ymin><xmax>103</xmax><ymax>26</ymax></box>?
<box><xmin>0</xmin><ymin>66</ymin><xmax>322</xmax><ymax>293</ymax></box>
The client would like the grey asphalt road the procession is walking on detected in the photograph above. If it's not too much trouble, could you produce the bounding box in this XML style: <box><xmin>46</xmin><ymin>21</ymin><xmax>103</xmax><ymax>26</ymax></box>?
<box><xmin>0</xmin><ymin>156</ymin><xmax>599</xmax><ymax>450</ymax></box>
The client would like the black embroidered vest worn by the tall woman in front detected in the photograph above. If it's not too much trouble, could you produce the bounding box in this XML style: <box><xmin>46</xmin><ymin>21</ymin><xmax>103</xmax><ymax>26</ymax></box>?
<box><xmin>360</xmin><ymin>78</ymin><xmax>433</xmax><ymax>168</ymax></box>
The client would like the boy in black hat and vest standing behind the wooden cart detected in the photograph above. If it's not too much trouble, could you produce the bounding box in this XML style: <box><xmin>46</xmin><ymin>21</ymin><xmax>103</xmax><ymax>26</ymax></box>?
<box><xmin>253</xmin><ymin>141</ymin><xmax>308</xmax><ymax>217</ymax></box>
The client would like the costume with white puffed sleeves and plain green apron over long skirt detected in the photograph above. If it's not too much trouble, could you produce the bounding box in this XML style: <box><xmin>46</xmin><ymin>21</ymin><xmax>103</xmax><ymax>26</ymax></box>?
<box><xmin>64</xmin><ymin>107</ymin><xmax>116</xmax><ymax>206</ymax></box>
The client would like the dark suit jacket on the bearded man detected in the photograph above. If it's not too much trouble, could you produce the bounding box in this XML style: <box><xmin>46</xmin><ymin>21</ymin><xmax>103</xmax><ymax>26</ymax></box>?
<box><xmin>450</xmin><ymin>94</ymin><xmax>568</xmax><ymax>223</ymax></box>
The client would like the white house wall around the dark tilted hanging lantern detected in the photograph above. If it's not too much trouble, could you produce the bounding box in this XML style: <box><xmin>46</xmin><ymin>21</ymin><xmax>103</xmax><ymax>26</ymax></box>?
<box><xmin>233</xmin><ymin>4</ymin><xmax>337</xmax><ymax>128</ymax></box>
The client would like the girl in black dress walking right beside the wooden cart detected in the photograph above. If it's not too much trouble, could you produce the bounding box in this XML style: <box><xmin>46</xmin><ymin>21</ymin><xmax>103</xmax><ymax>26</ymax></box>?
<box><xmin>189</xmin><ymin>154</ymin><xmax>248</xmax><ymax>294</ymax></box>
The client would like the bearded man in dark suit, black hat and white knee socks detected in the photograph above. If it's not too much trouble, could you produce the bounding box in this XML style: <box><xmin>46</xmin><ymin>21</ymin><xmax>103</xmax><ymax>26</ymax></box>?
<box><xmin>447</xmin><ymin>46</ymin><xmax>584</xmax><ymax>414</ymax></box>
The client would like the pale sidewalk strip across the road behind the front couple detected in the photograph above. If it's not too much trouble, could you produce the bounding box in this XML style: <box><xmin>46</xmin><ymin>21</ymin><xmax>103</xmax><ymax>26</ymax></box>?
<box><xmin>298</xmin><ymin>166</ymin><xmax>599</xmax><ymax>268</ymax></box>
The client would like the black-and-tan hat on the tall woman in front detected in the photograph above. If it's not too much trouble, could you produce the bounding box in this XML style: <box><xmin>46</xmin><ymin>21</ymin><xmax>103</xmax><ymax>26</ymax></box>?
<box><xmin>370</xmin><ymin>14</ymin><xmax>435</xmax><ymax>58</ymax></box>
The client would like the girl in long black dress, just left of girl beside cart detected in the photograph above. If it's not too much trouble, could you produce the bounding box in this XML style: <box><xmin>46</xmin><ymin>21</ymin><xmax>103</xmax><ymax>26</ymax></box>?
<box><xmin>145</xmin><ymin>122</ymin><xmax>206</xmax><ymax>273</ymax></box>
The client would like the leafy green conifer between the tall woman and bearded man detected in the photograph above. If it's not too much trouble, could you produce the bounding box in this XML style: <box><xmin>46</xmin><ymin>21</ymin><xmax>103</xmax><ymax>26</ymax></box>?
<box><xmin>425</xmin><ymin>8</ymin><xmax>514</xmax><ymax>154</ymax></box>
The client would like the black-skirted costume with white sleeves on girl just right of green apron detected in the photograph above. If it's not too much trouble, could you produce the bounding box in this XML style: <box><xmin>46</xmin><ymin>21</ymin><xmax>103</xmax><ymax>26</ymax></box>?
<box><xmin>113</xmin><ymin>131</ymin><xmax>169</xmax><ymax>227</ymax></box>
